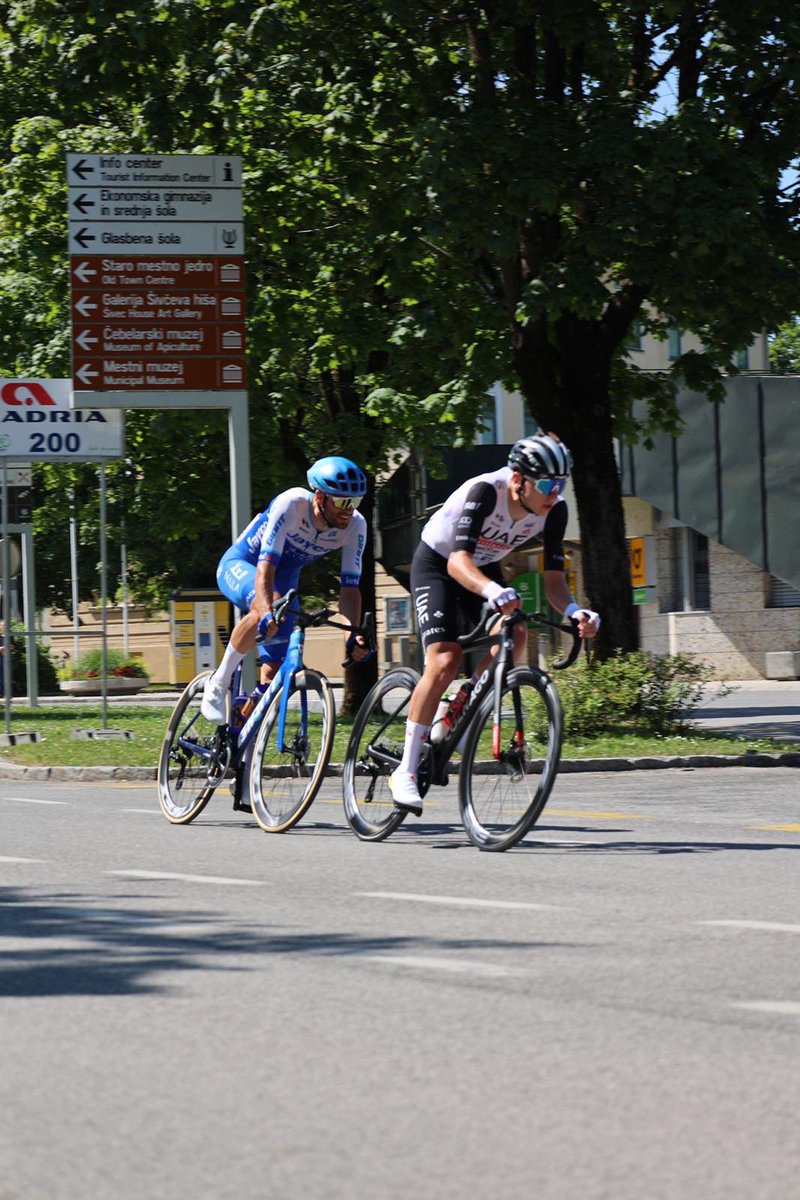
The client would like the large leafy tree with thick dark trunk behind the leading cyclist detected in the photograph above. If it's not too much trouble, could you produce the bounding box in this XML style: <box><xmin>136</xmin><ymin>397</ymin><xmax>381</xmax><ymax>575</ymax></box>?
<box><xmin>219</xmin><ymin>0</ymin><xmax>800</xmax><ymax>652</ymax></box>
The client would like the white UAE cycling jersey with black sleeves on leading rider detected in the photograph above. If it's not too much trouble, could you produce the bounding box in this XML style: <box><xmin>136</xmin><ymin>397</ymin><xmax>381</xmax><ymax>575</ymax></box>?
<box><xmin>421</xmin><ymin>467</ymin><xmax>567</xmax><ymax>571</ymax></box>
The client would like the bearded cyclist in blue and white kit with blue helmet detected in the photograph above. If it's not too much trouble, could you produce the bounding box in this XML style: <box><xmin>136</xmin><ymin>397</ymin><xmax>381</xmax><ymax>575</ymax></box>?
<box><xmin>200</xmin><ymin>455</ymin><xmax>372</xmax><ymax>725</ymax></box>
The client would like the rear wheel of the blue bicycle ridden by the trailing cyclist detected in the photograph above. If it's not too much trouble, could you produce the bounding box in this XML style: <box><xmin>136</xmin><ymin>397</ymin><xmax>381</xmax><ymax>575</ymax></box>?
<box><xmin>158</xmin><ymin>671</ymin><xmax>225</xmax><ymax>824</ymax></box>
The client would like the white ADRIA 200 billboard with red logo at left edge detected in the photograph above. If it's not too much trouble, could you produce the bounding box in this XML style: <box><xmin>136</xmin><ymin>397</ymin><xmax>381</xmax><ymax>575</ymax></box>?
<box><xmin>0</xmin><ymin>379</ymin><xmax>125</xmax><ymax>462</ymax></box>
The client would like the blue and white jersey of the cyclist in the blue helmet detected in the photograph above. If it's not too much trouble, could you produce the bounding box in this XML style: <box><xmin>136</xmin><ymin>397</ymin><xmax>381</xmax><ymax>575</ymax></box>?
<box><xmin>225</xmin><ymin>487</ymin><xmax>367</xmax><ymax>588</ymax></box>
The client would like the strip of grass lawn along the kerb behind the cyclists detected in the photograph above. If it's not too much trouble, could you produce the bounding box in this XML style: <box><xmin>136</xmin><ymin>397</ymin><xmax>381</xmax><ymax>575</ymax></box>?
<box><xmin>0</xmin><ymin>703</ymin><xmax>800</xmax><ymax>768</ymax></box>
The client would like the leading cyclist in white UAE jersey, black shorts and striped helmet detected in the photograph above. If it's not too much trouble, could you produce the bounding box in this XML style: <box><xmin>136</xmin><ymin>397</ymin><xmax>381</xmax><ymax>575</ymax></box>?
<box><xmin>389</xmin><ymin>433</ymin><xmax>600</xmax><ymax>816</ymax></box>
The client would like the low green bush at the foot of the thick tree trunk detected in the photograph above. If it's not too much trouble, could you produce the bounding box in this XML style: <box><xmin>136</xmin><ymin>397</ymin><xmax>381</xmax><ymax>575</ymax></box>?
<box><xmin>557</xmin><ymin>650</ymin><xmax>711</xmax><ymax>739</ymax></box>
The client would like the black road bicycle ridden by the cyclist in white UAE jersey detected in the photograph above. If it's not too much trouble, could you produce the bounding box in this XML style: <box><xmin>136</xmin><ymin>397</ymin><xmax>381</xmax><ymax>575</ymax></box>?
<box><xmin>343</xmin><ymin>606</ymin><xmax>581</xmax><ymax>851</ymax></box>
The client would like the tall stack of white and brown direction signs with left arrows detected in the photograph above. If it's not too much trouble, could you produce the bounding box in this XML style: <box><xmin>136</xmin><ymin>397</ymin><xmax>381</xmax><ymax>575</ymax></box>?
<box><xmin>67</xmin><ymin>154</ymin><xmax>245</xmax><ymax>408</ymax></box>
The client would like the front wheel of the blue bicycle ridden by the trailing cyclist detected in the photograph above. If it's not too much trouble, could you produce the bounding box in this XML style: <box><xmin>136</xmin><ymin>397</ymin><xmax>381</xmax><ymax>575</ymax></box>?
<box><xmin>249</xmin><ymin>667</ymin><xmax>336</xmax><ymax>833</ymax></box>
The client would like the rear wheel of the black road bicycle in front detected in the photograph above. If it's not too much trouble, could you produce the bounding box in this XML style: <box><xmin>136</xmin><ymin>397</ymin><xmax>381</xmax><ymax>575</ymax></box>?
<box><xmin>342</xmin><ymin>667</ymin><xmax>420</xmax><ymax>841</ymax></box>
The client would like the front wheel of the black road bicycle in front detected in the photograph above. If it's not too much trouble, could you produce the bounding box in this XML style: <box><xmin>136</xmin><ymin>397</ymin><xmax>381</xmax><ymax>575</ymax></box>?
<box><xmin>458</xmin><ymin>667</ymin><xmax>563</xmax><ymax>850</ymax></box>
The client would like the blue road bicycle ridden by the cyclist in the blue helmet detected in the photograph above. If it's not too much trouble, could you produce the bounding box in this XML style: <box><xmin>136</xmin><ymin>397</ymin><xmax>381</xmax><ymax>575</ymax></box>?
<box><xmin>158</xmin><ymin>588</ymin><xmax>374</xmax><ymax>833</ymax></box>
